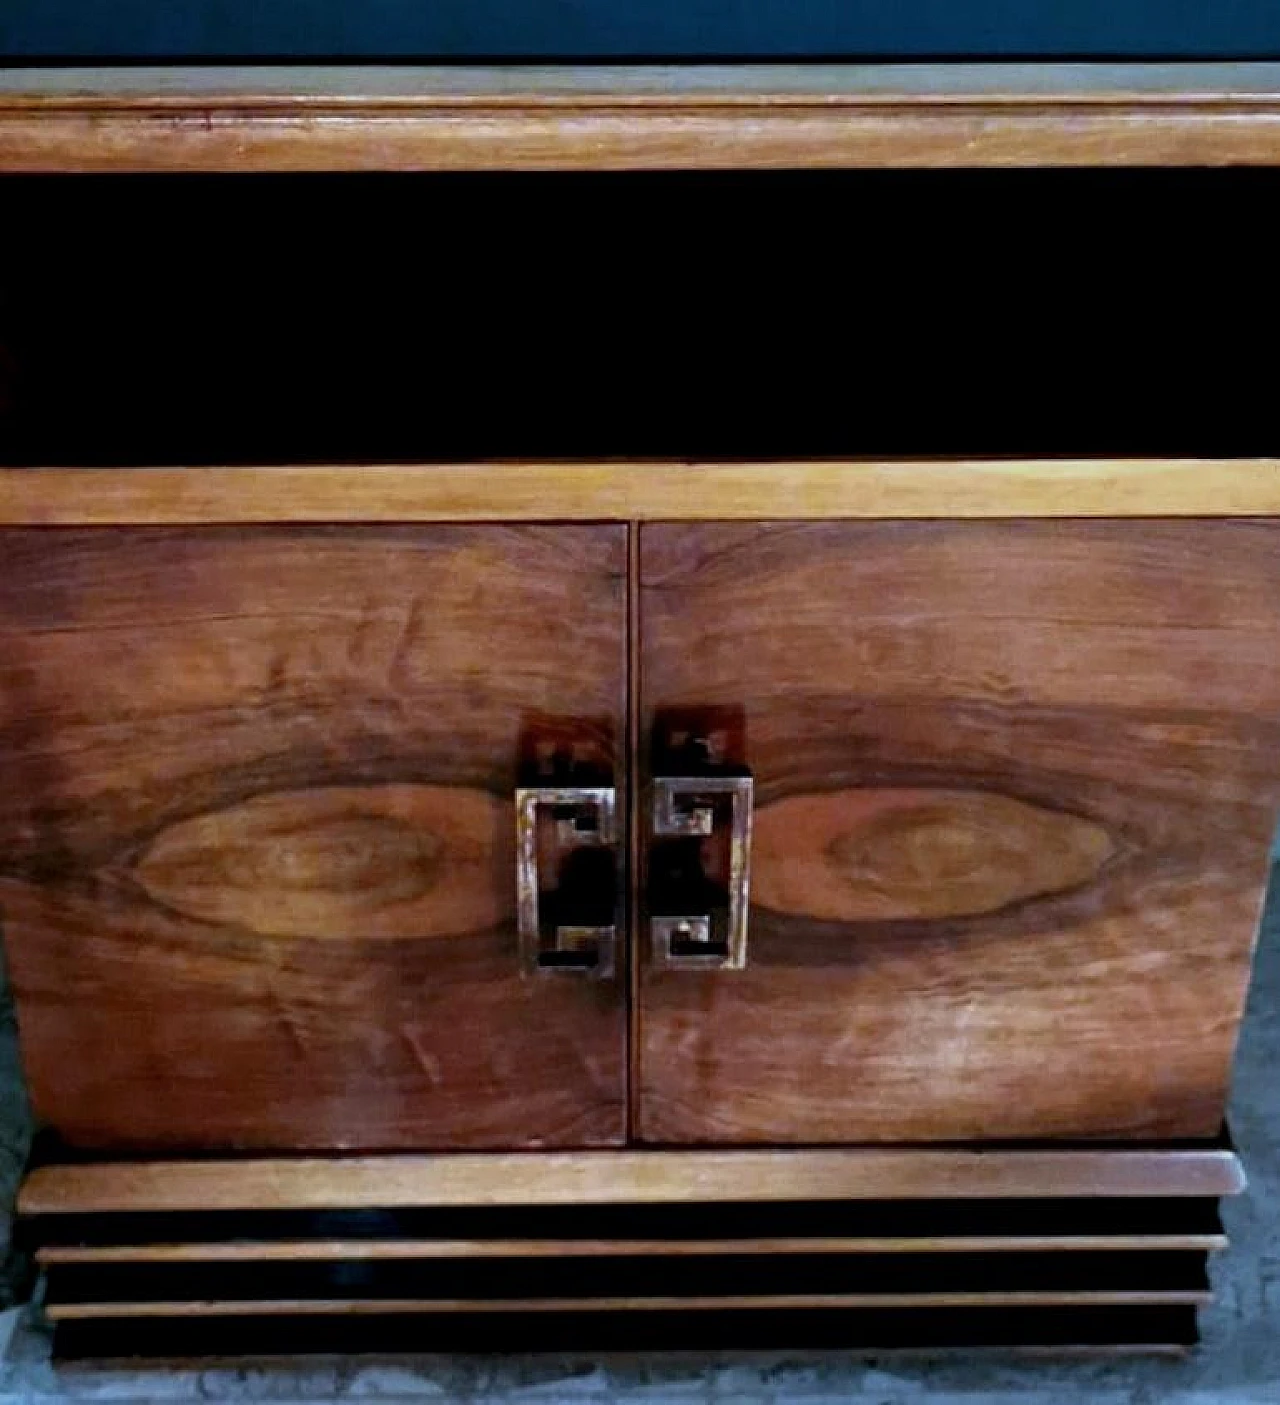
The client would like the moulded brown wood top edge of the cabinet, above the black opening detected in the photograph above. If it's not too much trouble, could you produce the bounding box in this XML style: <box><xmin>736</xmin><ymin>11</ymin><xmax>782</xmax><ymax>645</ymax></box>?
<box><xmin>0</xmin><ymin>63</ymin><xmax>1280</xmax><ymax>171</ymax></box>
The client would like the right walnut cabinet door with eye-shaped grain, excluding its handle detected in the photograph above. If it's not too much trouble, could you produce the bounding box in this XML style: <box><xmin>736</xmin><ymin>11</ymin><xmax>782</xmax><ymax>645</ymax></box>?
<box><xmin>634</xmin><ymin>521</ymin><xmax>1280</xmax><ymax>1142</ymax></box>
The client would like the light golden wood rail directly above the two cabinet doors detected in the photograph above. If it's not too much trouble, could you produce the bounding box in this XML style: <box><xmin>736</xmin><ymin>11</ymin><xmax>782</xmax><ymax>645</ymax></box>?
<box><xmin>0</xmin><ymin>458</ymin><xmax>1280</xmax><ymax>527</ymax></box>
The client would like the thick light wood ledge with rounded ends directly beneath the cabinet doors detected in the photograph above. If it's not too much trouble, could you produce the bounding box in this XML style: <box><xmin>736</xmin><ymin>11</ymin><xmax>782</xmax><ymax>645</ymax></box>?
<box><xmin>18</xmin><ymin>1148</ymin><xmax>1245</xmax><ymax>1215</ymax></box>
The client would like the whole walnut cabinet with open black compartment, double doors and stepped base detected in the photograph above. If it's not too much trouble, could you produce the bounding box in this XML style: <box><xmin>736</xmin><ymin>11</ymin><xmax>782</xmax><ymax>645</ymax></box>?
<box><xmin>0</xmin><ymin>65</ymin><xmax>1280</xmax><ymax>1353</ymax></box>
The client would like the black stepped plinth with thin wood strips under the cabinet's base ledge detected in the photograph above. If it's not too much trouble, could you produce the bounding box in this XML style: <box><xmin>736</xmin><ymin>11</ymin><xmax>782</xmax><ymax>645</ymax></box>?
<box><xmin>24</xmin><ymin>1149</ymin><xmax>1234</xmax><ymax>1357</ymax></box>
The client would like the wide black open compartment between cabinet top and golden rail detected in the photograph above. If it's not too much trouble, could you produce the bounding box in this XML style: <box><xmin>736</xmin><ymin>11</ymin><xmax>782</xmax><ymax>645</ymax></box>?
<box><xmin>0</xmin><ymin>170</ymin><xmax>1280</xmax><ymax>465</ymax></box>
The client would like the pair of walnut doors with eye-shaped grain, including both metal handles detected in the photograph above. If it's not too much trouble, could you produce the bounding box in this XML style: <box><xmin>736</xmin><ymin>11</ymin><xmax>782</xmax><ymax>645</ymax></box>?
<box><xmin>0</xmin><ymin>520</ymin><xmax>1280</xmax><ymax>1152</ymax></box>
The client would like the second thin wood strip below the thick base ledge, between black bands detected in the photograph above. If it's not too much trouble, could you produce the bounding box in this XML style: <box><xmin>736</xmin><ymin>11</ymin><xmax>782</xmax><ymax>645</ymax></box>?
<box><xmin>45</xmin><ymin>1288</ymin><xmax>1211</xmax><ymax>1322</ymax></box>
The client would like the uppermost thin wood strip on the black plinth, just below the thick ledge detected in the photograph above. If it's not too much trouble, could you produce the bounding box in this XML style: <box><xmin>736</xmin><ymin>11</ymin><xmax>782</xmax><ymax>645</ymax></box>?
<box><xmin>35</xmin><ymin>1234</ymin><xmax>1227</xmax><ymax>1267</ymax></box>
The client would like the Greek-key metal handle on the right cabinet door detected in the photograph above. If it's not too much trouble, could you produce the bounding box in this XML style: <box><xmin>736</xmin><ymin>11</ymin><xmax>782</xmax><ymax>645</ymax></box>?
<box><xmin>649</xmin><ymin>774</ymin><xmax>753</xmax><ymax>971</ymax></box>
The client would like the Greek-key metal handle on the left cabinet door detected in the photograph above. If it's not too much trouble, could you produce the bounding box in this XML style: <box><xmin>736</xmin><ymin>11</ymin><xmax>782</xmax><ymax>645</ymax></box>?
<box><xmin>516</xmin><ymin>785</ymin><xmax>618</xmax><ymax>981</ymax></box>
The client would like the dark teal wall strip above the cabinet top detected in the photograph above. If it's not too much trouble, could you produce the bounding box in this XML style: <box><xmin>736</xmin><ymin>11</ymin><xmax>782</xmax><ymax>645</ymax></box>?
<box><xmin>0</xmin><ymin>0</ymin><xmax>1280</xmax><ymax>60</ymax></box>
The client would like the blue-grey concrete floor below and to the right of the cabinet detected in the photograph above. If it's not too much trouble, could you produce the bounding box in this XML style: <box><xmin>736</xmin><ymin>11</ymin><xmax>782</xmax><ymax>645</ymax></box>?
<box><xmin>0</xmin><ymin>868</ymin><xmax>1280</xmax><ymax>1405</ymax></box>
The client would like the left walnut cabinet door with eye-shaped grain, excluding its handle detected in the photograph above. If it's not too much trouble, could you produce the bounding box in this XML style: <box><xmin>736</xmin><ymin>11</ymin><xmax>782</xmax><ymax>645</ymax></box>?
<box><xmin>0</xmin><ymin>527</ymin><xmax>627</xmax><ymax>1149</ymax></box>
